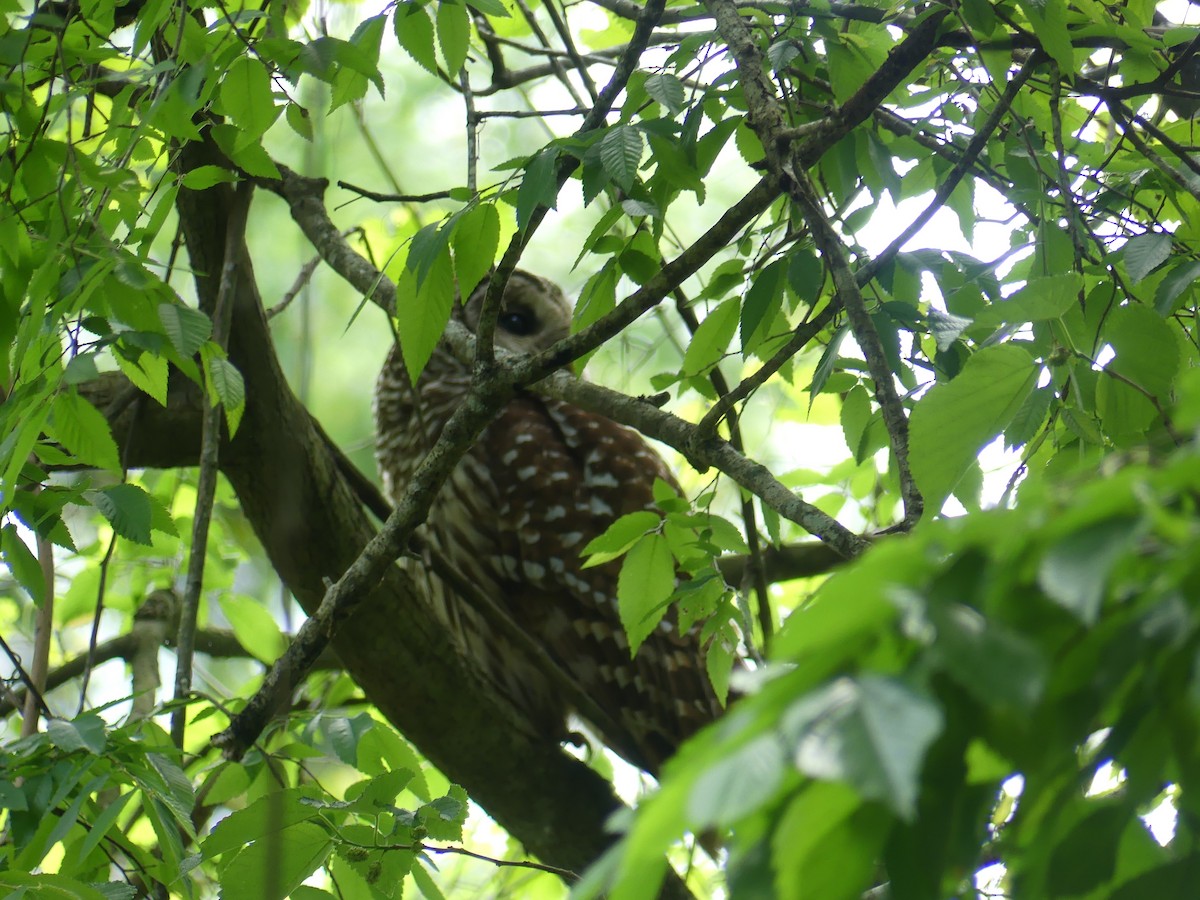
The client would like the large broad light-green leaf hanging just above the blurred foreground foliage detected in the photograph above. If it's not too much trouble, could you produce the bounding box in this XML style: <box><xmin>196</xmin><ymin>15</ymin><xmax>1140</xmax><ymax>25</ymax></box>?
<box><xmin>908</xmin><ymin>344</ymin><xmax>1038</xmax><ymax>514</ymax></box>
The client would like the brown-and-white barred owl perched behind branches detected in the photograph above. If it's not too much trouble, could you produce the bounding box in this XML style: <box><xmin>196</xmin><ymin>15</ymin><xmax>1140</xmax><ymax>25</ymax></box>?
<box><xmin>376</xmin><ymin>271</ymin><xmax>720</xmax><ymax>773</ymax></box>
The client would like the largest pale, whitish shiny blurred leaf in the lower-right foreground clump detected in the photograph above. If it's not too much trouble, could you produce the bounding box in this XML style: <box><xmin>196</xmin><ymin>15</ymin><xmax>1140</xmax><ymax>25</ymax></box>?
<box><xmin>785</xmin><ymin>674</ymin><xmax>943</xmax><ymax>820</ymax></box>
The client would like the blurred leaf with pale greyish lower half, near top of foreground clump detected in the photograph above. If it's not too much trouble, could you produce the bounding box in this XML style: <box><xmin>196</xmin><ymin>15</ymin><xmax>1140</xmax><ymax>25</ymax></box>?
<box><xmin>1038</xmin><ymin>518</ymin><xmax>1140</xmax><ymax>625</ymax></box>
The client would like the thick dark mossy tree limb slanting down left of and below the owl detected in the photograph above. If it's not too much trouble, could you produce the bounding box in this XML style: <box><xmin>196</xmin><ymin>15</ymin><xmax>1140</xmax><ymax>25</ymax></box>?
<box><xmin>169</xmin><ymin>148</ymin><xmax>648</xmax><ymax>871</ymax></box>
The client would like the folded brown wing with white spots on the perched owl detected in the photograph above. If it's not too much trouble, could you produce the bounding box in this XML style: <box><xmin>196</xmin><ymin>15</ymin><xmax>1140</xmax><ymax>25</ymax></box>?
<box><xmin>481</xmin><ymin>396</ymin><xmax>720</xmax><ymax>772</ymax></box>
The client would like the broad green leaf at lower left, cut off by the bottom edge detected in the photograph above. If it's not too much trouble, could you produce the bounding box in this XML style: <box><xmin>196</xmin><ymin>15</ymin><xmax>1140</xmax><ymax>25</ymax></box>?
<box><xmin>221</xmin><ymin>822</ymin><xmax>334</xmax><ymax>900</ymax></box>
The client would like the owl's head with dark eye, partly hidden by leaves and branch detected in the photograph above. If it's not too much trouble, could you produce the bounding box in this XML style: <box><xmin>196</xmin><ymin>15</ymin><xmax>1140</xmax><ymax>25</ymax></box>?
<box><xmin>462</xmin><ymin>269</ymin><xmax>571</xmax><ymax>353</ymax></box>
